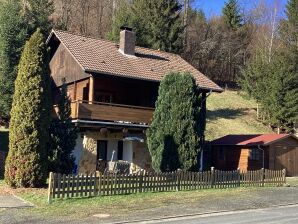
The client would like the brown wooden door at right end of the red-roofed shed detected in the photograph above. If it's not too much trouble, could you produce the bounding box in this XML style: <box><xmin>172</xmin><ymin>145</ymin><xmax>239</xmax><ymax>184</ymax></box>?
<box><xmin>275</xmin><ymin>146</ymin><xmax>298</xmax><ymax>176</ymax></box>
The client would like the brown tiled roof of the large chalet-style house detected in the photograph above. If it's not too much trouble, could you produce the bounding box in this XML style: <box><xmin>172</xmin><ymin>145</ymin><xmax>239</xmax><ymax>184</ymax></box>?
<box><xmin>47</xmin><ymin>30</ymin><xmax>223</xmax><ymax>92</ymax></box>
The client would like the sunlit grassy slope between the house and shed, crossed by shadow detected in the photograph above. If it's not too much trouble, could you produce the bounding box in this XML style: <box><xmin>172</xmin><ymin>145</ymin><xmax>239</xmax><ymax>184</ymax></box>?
<box><xmin>205</xmin><ymin>90</ymin><xmax>272</xmax><ymax>140</ymax></box>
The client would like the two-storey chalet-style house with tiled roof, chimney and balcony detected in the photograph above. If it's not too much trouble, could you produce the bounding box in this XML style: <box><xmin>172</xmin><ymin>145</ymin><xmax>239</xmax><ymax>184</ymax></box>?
<box><xmin>47</xmin><ymin>27</ymin><xmax>222</xmax><ymax>173</ymax></box>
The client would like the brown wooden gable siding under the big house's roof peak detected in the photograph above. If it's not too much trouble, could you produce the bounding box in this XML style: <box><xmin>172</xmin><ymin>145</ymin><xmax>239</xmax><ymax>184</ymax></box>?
<box><xmin>50</xmin><ymin>44</ymin><xmax>90</xmax><ymax>86</ymax></box>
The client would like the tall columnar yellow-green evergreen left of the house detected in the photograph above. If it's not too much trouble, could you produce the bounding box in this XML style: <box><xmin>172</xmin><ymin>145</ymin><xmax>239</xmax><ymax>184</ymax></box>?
<box><xmin>5</xmin><ymin>29</ymin><xmax>51</xmax><ymax>187</ymax></box>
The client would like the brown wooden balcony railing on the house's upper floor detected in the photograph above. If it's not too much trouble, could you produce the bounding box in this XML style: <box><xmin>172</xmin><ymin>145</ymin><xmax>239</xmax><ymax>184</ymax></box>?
<box><xmin>71</xmin><ymin>100</ymin><xmax>154</xmax><ymax>124</ymax></box>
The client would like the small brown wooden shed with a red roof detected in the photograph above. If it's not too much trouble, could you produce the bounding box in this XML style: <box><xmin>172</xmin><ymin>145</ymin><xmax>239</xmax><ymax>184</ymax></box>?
<box><xmin>210</xmin><ymin>134</ymin><xmax>298</xmax><ymax>176</ymax></box>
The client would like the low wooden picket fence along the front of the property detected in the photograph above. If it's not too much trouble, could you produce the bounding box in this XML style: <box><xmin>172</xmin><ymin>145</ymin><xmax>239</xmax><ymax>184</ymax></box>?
<box><xmin>48</xmin><ymin>168</ymin><xmax>286</xmax><ymax>203</ymax></box>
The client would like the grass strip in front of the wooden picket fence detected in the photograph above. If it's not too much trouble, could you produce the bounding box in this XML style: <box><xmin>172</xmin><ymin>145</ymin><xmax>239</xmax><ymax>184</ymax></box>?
<box><xmin>18</xmin><ymin>188</ymin><xmax>256</xmax><ymax>219</ymax></box>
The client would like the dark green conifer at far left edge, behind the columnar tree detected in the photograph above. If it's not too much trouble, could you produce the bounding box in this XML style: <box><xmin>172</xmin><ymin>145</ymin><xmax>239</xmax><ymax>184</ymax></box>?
<box><xmin>0</xmin><ymin>0</ymin><xmax>27</xmax><ymax>120</ymax></box>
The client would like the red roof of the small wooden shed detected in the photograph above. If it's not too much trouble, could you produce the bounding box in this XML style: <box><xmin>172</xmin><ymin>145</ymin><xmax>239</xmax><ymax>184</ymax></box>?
<box><xmin>210</xmin><ymin>134</ymin><xmax>297</xmax><ymax>146</ymax></box>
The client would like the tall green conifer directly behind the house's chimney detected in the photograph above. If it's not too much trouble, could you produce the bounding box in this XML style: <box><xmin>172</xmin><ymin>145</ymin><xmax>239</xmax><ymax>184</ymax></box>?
<box><xmin>108</xmin><ymin>0</ymin><xmax>184</xmax><ymax>53</ymax></box>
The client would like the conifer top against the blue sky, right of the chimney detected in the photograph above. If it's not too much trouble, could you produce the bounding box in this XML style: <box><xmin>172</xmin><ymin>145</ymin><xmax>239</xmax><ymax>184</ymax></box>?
<box><xmin>222</xmin><ymin>0</ymin><xmax>243</xmax><ymax>30</ymax></box>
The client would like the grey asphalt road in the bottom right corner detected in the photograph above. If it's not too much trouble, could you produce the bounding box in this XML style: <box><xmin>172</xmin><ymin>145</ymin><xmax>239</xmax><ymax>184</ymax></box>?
<box><xmin>134</xmin><ymin>205</ymin><xmax>298</xmax><ymax>224</ymax></box>
